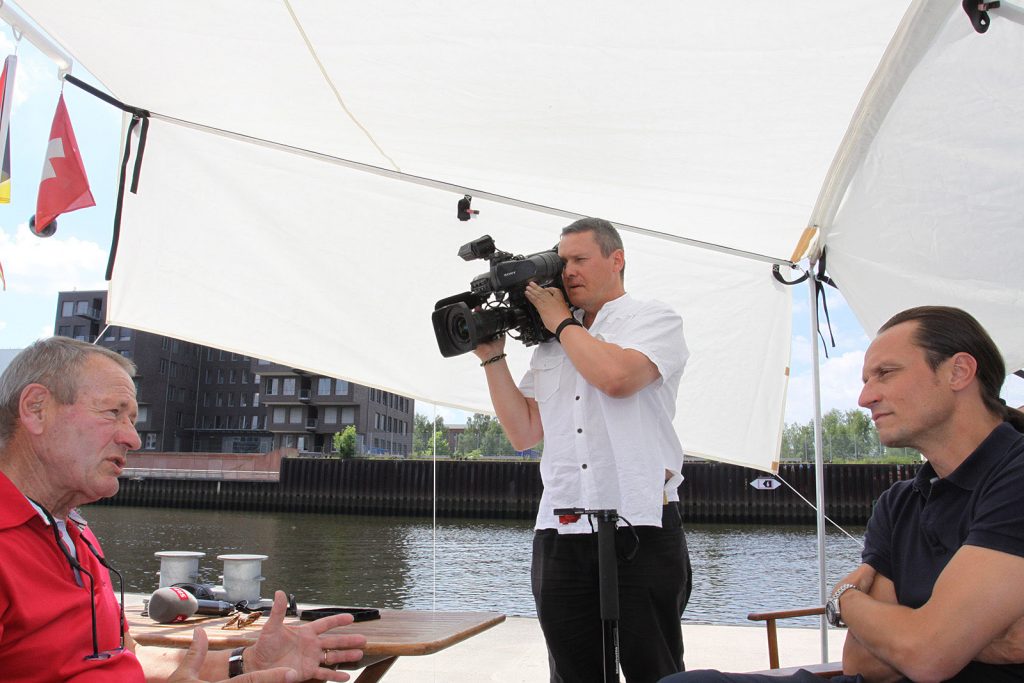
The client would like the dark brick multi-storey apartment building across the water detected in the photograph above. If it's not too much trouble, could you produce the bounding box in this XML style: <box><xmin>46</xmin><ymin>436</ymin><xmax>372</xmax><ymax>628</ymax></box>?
<box><xmin>54</xmin><ymin>291</ymin><xmax>415</xmax><ymax>456</ymax></box>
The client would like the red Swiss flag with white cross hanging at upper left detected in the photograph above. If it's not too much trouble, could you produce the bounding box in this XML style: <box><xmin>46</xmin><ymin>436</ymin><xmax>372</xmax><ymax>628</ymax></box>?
<box><xmin>35</xmin><ymin>93</ymin><xmax>96</xmax><ymax>233</ymax></box>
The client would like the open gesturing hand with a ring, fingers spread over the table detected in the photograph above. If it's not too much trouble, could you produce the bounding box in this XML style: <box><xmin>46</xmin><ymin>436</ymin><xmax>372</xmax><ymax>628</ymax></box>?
<box><xmin>244</xmin><ymin>591</ymin><xmax>367</xmax><ymax>681</ymax></box>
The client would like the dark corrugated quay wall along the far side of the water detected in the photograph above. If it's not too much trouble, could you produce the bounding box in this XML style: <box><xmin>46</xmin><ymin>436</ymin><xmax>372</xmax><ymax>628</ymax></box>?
<box><xmin>102</xmin><ymin>458</ymin><xmax>919</xmax><ymax>524</ymax></box>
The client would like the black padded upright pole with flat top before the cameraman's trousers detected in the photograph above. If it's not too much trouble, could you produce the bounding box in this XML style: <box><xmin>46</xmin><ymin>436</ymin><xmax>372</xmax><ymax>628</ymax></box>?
<box><xmin>554</xmin><ymin>508</ymin><xmax>618</xmax><ymax>683</ymax></box>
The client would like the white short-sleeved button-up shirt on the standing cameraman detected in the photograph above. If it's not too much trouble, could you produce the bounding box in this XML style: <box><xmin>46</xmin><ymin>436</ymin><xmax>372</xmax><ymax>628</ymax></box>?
<box><xmin>519</xmin><ymin>294</ymin><xmax>689</xmax><ymax>533</ymax></box>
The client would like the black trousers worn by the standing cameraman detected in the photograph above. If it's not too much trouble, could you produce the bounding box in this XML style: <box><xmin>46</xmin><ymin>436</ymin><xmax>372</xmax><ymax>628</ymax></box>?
<box><xmin>531</xmin><ymin>503</ymin><xmax>692</xmax><ymax>683</ymax></box>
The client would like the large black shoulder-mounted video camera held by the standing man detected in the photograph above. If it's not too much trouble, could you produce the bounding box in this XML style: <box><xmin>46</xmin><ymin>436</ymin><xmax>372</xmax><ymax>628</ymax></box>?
<box><xmin>431</xmin><ymin>234</ymin><xmax>565</xmax><ymax>358</ymax></box>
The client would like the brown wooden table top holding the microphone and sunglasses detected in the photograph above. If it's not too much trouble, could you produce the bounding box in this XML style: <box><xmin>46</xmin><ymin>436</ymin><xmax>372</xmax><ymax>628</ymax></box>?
<box><xmin>125</xmin><ymin>607</ymin><xmax>505</xmax><ymax>683</ymax></box>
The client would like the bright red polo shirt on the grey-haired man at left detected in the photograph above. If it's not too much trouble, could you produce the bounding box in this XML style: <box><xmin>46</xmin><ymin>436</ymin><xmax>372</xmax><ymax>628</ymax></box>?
<box><xmin>0</xmin><ymin>473</ymin><xmax>144</xmax><ymax>683</ymax></box>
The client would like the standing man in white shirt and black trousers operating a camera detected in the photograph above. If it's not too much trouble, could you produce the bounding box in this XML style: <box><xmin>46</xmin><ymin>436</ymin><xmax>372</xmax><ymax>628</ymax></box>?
<box><xmin>474</xmin><ymin>218</ymin><xmax>691</xmax><ymax>683</ymax></box>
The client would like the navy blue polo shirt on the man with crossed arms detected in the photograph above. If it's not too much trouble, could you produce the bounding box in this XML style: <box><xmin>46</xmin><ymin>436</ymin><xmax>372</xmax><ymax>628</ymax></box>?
<box><xmin>862</xmin><ymin>422</ymin><xmax>1024</xmax><ymax>681</ymax></box>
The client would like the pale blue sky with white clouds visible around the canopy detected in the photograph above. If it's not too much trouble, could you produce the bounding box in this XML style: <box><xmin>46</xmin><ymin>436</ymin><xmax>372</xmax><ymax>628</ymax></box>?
<box><xmin>0</xmin><ymin>33</ymin><xmax>1024</xmax><ymax>424</ymax></box>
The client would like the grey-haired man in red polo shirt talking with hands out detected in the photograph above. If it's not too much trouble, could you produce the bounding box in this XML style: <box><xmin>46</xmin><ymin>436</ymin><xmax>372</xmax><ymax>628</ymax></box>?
<box><xmin>0</xmin><ymin>337</ymin><xmax>366</xmax><ymax>683</ymax></box>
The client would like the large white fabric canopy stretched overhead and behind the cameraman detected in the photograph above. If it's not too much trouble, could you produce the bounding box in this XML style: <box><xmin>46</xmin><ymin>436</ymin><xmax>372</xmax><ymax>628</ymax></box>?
<box><xmin>9</xmin><ymin>0</ymin><xmax>1024</xmax><ymax>470</ymax></box>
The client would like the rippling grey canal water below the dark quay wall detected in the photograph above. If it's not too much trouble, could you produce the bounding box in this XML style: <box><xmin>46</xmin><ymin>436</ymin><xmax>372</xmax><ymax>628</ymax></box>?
<box><xmin>83</xmin><ymin>506</ymin><xmax>863</xmax><ymax>627</ymax></box>
